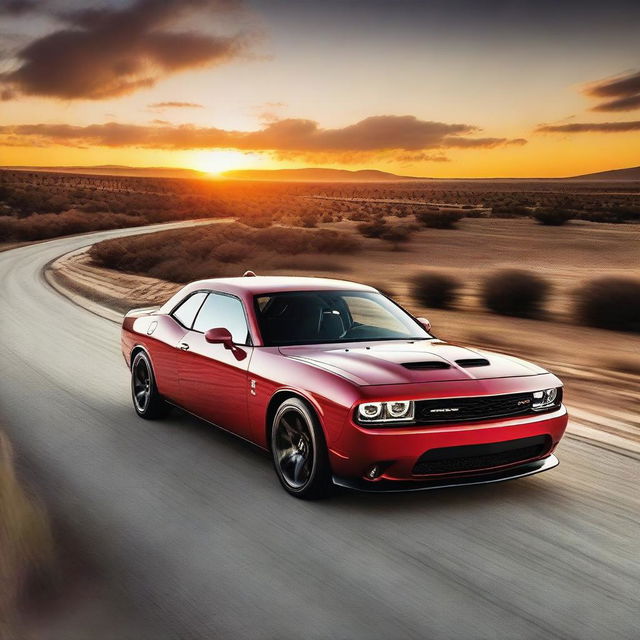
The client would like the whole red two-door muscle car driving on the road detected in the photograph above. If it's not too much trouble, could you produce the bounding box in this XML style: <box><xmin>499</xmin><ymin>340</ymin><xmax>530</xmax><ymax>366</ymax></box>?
<box><xmin>122</xmin><ymin>274</ymin><xmax>567</xmax><ymax>498</ymax></box>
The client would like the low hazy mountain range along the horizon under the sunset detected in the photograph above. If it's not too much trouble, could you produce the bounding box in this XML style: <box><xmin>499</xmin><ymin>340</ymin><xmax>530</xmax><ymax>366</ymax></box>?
<box><xmin>0</xmin><ymin>165</ymin><xmax>640</xmax><ymax>182</ymax></box>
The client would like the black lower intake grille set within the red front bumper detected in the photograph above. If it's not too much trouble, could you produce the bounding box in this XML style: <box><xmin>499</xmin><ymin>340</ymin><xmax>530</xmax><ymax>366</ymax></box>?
<box><xmin>413</xmin><ymin>435</ymin><xmax>551</xmax><ymax>475</ymax></box>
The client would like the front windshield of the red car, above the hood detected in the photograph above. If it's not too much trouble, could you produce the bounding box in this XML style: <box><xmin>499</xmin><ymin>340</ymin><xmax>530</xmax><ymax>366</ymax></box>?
<box><xmin>255</xmin><ymin>291</ymin><xmax>432</xmax><ymax>346</ymax></box>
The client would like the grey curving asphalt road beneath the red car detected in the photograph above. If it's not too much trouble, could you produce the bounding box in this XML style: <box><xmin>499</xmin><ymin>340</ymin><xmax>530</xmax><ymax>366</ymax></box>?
<box><xmin>0</xmin><ymin>222</ymin><xmax>640</xmax><ymax>640</ymax></box>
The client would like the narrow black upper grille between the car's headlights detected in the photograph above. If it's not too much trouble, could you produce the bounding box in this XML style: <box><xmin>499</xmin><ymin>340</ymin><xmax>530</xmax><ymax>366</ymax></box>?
<box><xmin>415</xmin><ymin>393</ymin><xmax>560</xmax><ymax>424</ymax></box>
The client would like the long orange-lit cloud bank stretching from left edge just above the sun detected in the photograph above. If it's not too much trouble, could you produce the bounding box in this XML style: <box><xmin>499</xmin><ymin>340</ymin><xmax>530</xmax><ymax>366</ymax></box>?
<box><xmin>0</xmin><ymin>116</ymin><xmax>521</xmax><ymax>154</ymax></box>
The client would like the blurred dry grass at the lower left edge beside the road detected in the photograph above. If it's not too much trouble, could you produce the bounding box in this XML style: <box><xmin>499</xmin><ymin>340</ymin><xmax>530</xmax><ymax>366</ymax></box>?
<box><xmin>0</xmin><ymin>433</ymin><xmax>54</xmax><ymax>640</ymax></box>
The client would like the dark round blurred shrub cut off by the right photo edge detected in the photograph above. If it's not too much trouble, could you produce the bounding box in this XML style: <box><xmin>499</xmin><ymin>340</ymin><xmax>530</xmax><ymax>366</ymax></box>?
<box><xmin>574</xmin><ymin>276</ymin><xmax>640</xmax><ymax>331</ymax></box>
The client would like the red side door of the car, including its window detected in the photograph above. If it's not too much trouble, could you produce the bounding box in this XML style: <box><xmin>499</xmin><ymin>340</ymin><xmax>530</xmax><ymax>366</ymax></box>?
<box><xmin>178</xmin><ymin>292</ymin><xmax>253</xmax><ymax>439</ymax></box>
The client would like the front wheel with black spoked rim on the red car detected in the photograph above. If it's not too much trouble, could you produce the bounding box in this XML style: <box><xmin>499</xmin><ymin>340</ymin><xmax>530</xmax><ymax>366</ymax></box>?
<box><xmin>271</xmin><ymin>398</ymin><xmax>333</xmax><ymax>500</ymax></box>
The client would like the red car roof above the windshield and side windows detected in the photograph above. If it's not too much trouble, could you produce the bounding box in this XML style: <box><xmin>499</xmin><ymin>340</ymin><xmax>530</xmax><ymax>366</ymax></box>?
<box><xmin>189</xmin><ymin>276</ymin><xmax>376</xmax><ymax>295</ymax></box>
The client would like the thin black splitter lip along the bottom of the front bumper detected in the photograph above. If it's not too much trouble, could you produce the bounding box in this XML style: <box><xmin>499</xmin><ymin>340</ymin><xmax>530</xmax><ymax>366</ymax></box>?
<box><xmin>333</xmin><ymin>455</ymin><xmax>560</xmax><ymax>493</ymax></box>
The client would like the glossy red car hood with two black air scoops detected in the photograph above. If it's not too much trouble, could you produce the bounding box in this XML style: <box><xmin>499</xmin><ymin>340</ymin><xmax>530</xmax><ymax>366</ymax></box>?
<box><xmin>280</xmin><ymin>340</ymin><xmax>547</xmax><ymax>386</ymax></box>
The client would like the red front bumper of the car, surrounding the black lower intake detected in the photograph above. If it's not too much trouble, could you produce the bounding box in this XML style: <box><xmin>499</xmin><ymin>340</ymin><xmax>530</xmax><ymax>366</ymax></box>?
<box><xmin>330</xmin><ymin>406</ymin><xmax>568</xmax><ymax>484</ymax></box>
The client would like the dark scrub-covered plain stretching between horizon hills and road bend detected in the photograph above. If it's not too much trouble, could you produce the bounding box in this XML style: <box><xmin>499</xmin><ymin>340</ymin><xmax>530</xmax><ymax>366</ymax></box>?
<box><xmin>0</xmin><ymin>170</ymin><xmax>640</xmax><ymax>241</ymax></box>
